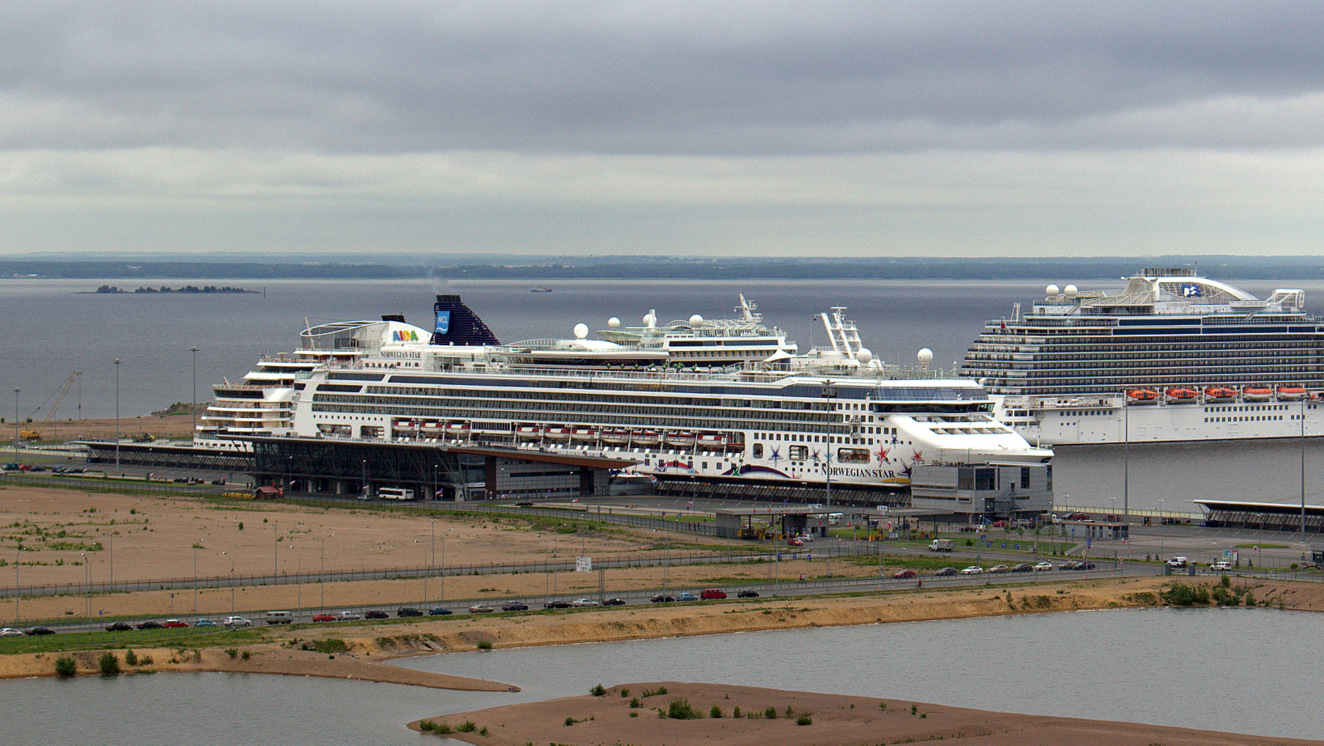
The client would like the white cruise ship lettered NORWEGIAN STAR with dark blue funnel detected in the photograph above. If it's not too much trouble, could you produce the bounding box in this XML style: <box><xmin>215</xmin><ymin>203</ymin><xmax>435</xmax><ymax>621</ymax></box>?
<box><xmin>207</xmin><ymin>295</ymin><xmax>1053</xmax><ymax>514</ymax></box>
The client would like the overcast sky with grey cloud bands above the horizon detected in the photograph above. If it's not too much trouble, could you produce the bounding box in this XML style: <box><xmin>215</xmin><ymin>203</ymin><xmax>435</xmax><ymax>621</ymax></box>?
<box><xmin>0</xmin><ymin>0</ymin><xmax>1324</xmax><ymax>257</ymax></box>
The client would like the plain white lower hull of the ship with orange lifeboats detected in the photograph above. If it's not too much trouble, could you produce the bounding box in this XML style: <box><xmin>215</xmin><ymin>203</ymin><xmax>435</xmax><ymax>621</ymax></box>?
<box><xmin>994</xmin><ymin>396</ymin><xmax>1324</xmax><ymax>447</ymax></box>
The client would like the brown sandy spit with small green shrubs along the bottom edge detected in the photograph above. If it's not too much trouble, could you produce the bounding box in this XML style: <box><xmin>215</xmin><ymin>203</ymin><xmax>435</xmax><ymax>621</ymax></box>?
<box><xmin>423</xmin><ymin>681</ymin><xmax>1313</xmax><ymax>746</ymax></box>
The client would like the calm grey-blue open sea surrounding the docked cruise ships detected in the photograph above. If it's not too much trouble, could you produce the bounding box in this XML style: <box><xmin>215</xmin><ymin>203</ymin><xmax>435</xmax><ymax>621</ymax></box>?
<box><xmin>0</xmin><ymin>278</ymin><xmax>1324</xmax><ymax>510</ymax></box>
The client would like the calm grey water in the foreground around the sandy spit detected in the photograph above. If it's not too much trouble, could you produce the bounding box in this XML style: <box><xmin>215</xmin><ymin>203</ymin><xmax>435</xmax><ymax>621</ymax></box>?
<box><xmin>0</xmin><ymin>610</ymin><xmax>1324</xmax><ymax>745</ymax></box>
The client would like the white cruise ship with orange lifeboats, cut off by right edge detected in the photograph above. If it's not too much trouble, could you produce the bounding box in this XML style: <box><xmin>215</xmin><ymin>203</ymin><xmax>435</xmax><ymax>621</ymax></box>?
<box><xmin>961</xmin><ymin>268</ymin><xmax>1324</xmax><ymax>445</ymax></box>
